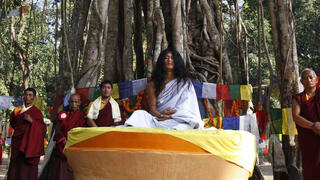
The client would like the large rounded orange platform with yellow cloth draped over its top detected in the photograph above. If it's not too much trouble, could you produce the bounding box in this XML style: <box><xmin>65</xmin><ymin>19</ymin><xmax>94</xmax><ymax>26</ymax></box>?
<box><xmin>64</xmin><ymin>127</ymin><xmax>257</xmax><ymax>180</ymax></box>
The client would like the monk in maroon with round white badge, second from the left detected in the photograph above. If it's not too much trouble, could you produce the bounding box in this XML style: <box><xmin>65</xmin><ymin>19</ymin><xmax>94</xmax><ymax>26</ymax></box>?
<box><xmin>39</xmin><ymin>94</ymin><xmax>85</xmax><ymax>180</ymax></box>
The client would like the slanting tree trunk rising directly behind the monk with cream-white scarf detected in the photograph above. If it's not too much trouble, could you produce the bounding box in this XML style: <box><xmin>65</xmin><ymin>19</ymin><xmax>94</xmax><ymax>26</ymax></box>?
<box><xmin>77</xmin><ymin>0</ymin><xmax>109</xmax><ymax>87</ymax></box>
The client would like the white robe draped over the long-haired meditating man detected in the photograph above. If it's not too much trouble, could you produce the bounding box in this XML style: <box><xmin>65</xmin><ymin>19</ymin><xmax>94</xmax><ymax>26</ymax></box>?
<box><xmin>125</xmin><ymin>79</ymin><xmax>204</xmax><ymax>130</ymax></box>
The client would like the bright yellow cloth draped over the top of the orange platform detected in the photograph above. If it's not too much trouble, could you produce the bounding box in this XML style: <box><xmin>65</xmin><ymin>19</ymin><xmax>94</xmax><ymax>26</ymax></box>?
<box><xmin>65</xmin><ymin>127</ymin><xmax>257</xmax><ymax>174</ymax></box>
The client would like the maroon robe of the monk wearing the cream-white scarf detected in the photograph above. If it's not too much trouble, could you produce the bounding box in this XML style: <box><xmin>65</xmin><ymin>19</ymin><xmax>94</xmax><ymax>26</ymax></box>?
<box><xmin>95</xmin><ymin>102</ymin><xmax>124</xmax><ymax>127</ymax></box>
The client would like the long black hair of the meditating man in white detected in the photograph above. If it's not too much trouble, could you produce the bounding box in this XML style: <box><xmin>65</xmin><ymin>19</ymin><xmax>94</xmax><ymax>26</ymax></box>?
<box><xmin>151</xmin><ymin>48</ymin><xmax>190</xmax><ymax>95</ymax></box>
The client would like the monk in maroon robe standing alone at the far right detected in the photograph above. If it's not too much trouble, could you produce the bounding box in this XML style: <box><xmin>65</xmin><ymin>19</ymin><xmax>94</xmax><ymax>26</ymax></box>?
<box><xmin>292</xmin><ymin>69</ymin><xmax>320</xmax><ymax>180</ymax></box>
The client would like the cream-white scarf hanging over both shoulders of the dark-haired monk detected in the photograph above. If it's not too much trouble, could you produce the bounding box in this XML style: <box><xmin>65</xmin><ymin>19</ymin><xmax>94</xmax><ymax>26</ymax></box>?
<box><xmin>87</xmin><ymin>96</ymin><xmax>121</xmax><ymax>122</ymax></box>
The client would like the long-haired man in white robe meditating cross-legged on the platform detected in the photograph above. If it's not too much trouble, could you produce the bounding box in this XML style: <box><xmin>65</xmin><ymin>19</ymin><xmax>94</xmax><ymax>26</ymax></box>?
<box><xmin>125</xmin><ymin>49</ymin><xmax>204</xmax><ymax>129</ymax></box>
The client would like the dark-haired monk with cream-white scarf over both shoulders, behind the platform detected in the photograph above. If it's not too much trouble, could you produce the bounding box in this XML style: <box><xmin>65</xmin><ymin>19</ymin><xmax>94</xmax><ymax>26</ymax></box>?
<box><xmin>87</xmin><ymin>80</ymin><xmax>121</xmax><ymax>127</ymax></box>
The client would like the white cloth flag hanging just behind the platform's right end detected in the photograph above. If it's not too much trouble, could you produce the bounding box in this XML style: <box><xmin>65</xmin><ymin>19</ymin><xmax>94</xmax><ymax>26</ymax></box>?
<box><xmin>239</xmin><ymin>113</ymin><xmax>260</xmax><ymax>144</ymax></box>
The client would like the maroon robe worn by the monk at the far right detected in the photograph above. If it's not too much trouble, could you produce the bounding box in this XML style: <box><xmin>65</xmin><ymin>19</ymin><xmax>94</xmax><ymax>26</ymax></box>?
<box><xmin>294</xmin><ymin>89</ymin><xmax>320</xmax><ymax>180</ymax></box>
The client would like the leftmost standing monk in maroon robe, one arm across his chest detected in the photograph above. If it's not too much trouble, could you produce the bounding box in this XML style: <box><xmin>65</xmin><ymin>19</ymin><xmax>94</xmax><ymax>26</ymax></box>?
<box><xmin>8</xmin><ymin>88</ymin><xmax>46</xmax><ymax>180</ymax></box>
